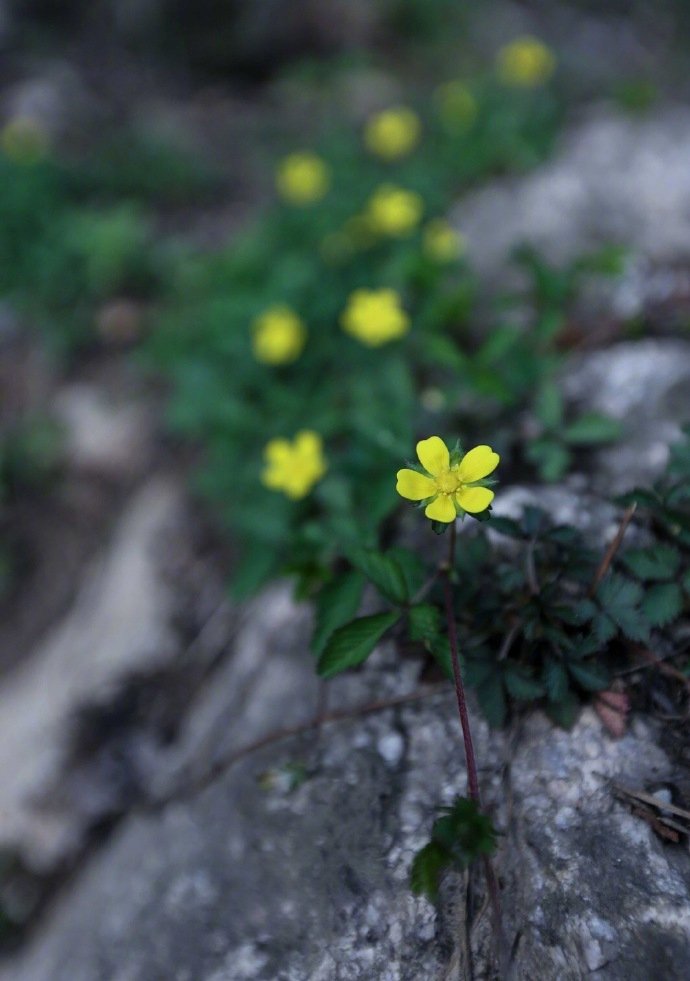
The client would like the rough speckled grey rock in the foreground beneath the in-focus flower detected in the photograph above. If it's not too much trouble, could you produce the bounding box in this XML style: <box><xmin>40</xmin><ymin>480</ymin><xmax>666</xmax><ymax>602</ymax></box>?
<box><xmin>5</xmin><ymin>628</ymin><xmax>690</xmax><ymax>981</ymax></box>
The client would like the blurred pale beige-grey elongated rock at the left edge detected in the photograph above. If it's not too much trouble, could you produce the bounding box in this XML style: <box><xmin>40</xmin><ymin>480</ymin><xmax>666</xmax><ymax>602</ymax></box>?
<box><xmin>0</xmin><ymin>478</ymin><xmax>182</xmax><ymax>871</ymax></box>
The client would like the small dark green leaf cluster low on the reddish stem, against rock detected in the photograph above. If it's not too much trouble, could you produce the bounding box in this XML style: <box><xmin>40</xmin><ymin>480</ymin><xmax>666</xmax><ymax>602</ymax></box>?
<box><xmin>410</xmin><ymin>797</ymin><xmax>496</xmax><ymax>902</ymax></box>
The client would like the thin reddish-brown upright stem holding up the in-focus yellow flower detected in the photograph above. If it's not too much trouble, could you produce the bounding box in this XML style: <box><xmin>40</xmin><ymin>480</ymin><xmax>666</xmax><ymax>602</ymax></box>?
<box><xmin>442</xmin><ymin>522</ymin><xmax>508</xmax><ymax>975</ymax></box>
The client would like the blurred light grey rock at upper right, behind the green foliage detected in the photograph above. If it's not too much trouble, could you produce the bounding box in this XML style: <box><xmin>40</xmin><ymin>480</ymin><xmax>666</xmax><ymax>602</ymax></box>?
<box><xmin>454</xmin><ymin>107</ymin><xmax>690</xmax><ymax>302</ymax></box>
